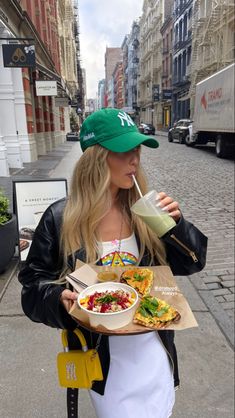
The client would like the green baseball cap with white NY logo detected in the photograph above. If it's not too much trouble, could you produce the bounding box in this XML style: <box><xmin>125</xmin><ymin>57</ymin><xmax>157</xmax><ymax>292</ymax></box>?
<box><xmin>80</xmin><ymin>108</ymin><xmax>159</xmax><ymax>152</ymax></box>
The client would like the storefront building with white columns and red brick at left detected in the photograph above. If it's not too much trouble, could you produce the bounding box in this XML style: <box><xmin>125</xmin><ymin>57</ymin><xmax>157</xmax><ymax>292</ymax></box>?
<box><xmin>0</xmin><ymin>2</ymin><xmax>69</xmax><ymax>176</ymax></box>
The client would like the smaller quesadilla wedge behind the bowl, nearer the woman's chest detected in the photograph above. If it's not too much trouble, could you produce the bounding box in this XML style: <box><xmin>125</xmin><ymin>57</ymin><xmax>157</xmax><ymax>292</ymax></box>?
<box><xmin>120</xmin><ymin>267</ymin><xmax>153</xmax><ymax>296</ymax></box>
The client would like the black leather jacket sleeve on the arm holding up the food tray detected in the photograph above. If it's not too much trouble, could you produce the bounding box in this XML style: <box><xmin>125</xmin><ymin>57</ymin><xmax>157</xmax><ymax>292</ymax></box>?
<box><xmin>18</xmin><ymin>202</ymin><xmax>76</xmax><ymax>329</ymax></box>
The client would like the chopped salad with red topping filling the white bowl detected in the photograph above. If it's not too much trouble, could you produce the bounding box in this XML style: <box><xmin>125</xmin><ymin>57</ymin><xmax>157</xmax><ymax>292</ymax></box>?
<box><xmin>80</xmin><ymin>289</ymin><xmax>136</xmax><ymax>313</ymax></box>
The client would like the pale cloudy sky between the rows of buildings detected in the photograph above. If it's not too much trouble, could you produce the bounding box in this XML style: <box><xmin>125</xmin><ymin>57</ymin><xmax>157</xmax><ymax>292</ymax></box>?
<box><xmin>78</xmin><ymin>0</ymin><xmax>143</xmax><ymax>98</ymax></box>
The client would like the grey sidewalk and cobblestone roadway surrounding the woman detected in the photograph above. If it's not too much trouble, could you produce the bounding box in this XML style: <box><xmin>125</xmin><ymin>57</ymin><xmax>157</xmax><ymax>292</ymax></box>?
<box><xmin>0</xmin><ymin>132</ymin><xmax>234</xmax><ymax>418</ymax></box>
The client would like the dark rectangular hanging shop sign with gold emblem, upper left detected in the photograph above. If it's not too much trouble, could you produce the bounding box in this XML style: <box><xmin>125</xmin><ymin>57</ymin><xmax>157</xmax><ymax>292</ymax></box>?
<box><xmin>2</xmin><ymin>44</ymin><xmax>36</xmax><ymax>67</ymax></box>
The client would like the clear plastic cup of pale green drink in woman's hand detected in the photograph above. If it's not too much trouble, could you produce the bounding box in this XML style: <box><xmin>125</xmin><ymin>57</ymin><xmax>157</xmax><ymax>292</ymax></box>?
<box><xmin>131</xmin><ymin>190</ymin><xmax>176</xmax><ymax>238</ymax></box>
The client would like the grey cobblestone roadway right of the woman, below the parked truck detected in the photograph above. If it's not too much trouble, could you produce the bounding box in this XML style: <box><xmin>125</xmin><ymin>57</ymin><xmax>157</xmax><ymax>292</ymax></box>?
<box><xmin>143</xmin><ymin>135</ymin><xmax>234</xmax><ymax>342</ymax></box>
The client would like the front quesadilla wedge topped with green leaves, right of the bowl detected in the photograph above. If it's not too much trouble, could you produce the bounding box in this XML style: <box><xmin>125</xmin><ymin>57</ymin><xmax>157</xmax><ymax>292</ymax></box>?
<box><xmin>133</xmin><ymin>295</ymin><xmax>180</xmax><ymax>329</ymax></box>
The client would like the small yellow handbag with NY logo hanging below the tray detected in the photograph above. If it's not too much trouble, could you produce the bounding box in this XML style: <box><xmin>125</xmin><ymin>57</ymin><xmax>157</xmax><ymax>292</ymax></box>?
<box><xmin>57</xmin><ymin>329</ymin><xmax>103</xmax><ymax>389</ymax></box>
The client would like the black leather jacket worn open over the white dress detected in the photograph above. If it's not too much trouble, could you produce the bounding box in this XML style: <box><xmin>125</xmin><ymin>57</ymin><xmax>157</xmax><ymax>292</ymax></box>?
<box><xmin>19</xmin><ymin>199</ymin><xmax>207</xmax><ymax>394</ymax></box>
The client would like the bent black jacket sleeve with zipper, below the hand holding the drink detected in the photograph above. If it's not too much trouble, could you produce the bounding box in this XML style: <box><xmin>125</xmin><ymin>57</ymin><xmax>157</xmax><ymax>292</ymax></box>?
<box><xmin>163</xmin><ymin>216</ymin><xmax>207</xmax><ymax>276</ymax></box>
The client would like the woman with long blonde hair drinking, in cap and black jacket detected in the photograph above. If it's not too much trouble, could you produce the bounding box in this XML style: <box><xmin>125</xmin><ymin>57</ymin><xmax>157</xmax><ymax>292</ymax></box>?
<box><xmin>19</xmin><ymin>109</ymin><xmax>207</xmax><ymax>418</ymax></box>
